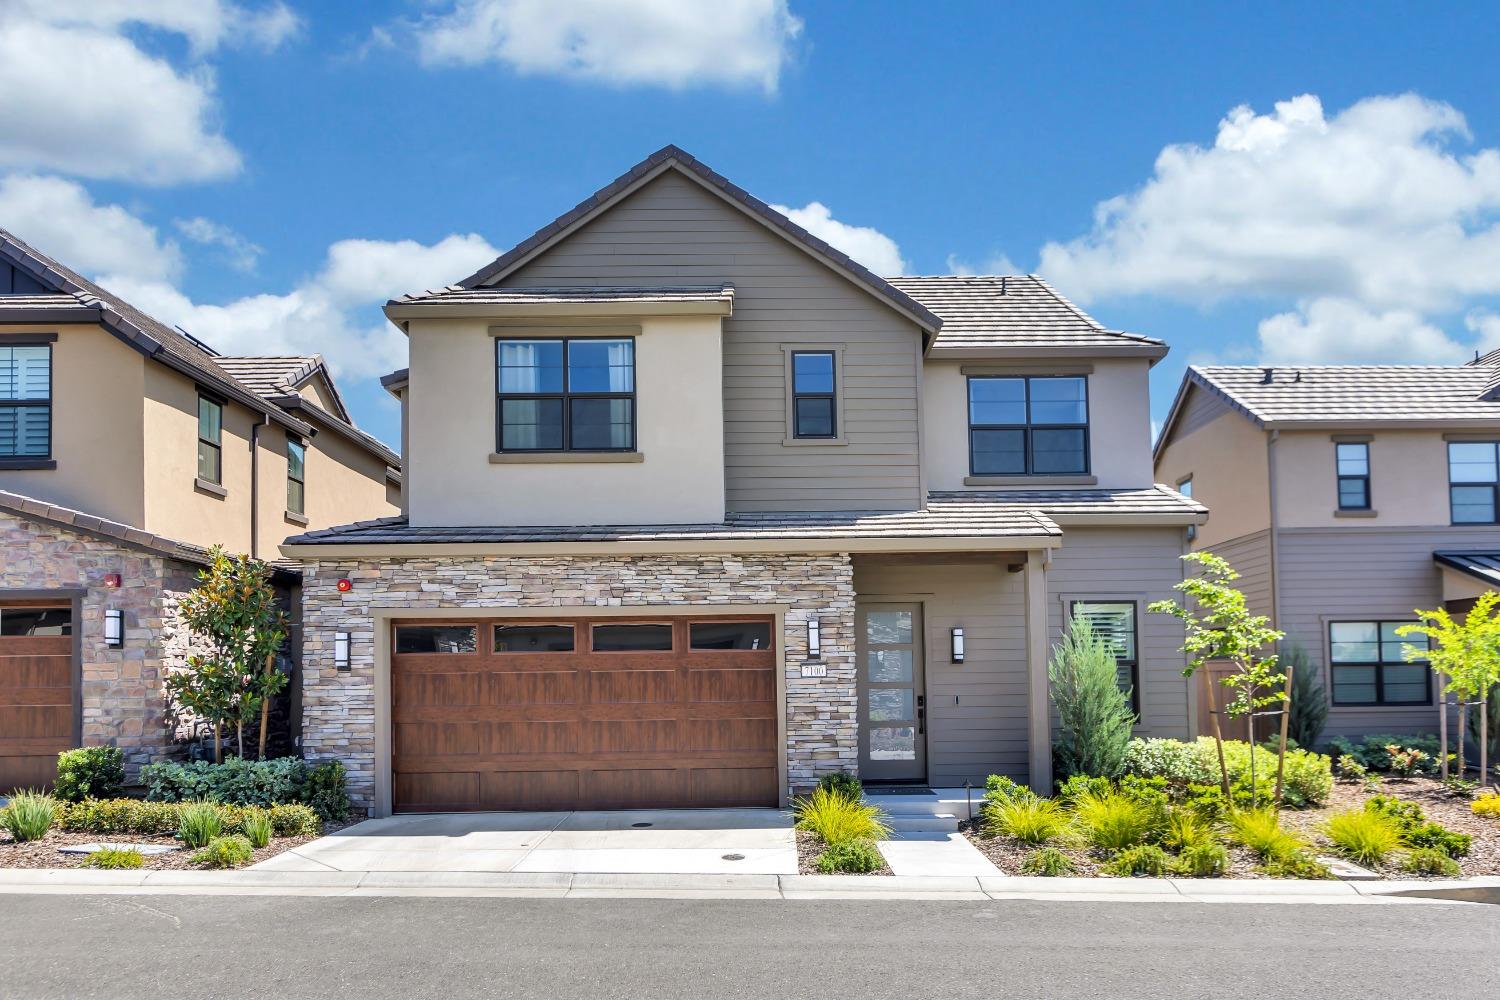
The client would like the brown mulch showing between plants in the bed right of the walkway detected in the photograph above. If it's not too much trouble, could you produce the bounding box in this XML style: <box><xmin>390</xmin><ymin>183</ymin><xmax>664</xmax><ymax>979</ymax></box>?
<box><xmin>966</xmin><ymin>778</ymin><xmax>1500</xmax><ymax>880</ymax></box>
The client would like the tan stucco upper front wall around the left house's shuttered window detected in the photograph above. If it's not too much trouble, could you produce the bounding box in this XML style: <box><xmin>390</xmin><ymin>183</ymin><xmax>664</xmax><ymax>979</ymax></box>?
<box><xmin>0</xmin><ymin>325</ymin><xmax>147</xmax><ymax>525</ymax></box>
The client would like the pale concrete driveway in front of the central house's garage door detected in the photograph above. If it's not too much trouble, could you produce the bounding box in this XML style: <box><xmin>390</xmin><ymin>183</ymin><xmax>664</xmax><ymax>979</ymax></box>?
<box><xmin>255</xmin><ymin>810</ymin><xmax>797</xmax><ymax>876</ymax></box>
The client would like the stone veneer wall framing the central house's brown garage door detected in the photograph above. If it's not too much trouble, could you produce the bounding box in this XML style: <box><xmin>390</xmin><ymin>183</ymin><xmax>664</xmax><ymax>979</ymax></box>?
<box><xmin>302</xmin><ymin>553</ymin><xmax>858</xmax><ymax>808</ymax></box>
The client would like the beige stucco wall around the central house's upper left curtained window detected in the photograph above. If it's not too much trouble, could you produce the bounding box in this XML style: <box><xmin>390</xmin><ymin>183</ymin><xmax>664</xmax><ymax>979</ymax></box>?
<box><xmin>407</xmin><ymin>316</ymin><xmax>725</xmax><ymax>525</ymax></box>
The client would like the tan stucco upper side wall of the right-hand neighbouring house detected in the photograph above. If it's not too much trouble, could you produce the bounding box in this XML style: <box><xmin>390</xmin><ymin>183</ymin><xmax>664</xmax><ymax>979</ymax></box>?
<box><xmin>1157</xmin><ymin>387</ymin><xmax>1271</xmax><ymax>549</ymax></box>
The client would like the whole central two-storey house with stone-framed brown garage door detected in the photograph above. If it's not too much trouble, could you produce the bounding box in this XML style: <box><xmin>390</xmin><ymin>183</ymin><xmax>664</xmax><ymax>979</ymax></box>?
<box><xmin>284</xmin><ymin>147</ymin><xmax>1206</xmax><ymax>814</ymax></box>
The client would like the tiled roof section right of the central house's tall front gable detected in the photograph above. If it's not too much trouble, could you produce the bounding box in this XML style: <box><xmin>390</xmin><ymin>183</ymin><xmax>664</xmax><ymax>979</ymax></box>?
<box><xmin>890</xmin><ymin>274</ymin><xmax>1167</xmax><ymax>360</ymax></box>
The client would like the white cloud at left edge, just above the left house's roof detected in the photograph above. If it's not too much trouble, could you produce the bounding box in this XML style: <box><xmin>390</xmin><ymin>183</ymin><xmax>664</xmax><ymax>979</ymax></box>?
<box><xmin>0</xmin><ymin>174</ymin><xmax>183</xmax><ymax>282</ymax></box>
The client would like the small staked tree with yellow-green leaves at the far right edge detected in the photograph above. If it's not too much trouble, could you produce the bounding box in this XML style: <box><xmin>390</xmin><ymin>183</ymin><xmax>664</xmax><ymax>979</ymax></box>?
<box><xmin>1397</xmin><ymin>591</ymin><xmax>1500</xmax><ymax>784</ymax></box>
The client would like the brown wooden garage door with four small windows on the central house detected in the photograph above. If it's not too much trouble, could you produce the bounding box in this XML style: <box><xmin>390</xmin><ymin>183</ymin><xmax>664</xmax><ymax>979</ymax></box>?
<box><xmin>392</xmin><ymin>618</ymin><xmax>779</xmax><ymax>813</ymax></box>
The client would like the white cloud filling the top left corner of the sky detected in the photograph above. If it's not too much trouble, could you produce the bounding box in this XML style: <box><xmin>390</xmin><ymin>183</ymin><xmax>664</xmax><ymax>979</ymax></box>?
<box><xmin>0</xmin><ymin>0</ymin><xmax>297</xmax><ymax>184</ymax></box>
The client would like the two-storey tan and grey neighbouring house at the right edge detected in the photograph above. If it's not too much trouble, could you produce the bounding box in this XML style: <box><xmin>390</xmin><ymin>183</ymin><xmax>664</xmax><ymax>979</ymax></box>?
<box><xmin>1157</xmin><ymin>355</ymin><xmax>1500</xmax><ymax>736</ymax></box>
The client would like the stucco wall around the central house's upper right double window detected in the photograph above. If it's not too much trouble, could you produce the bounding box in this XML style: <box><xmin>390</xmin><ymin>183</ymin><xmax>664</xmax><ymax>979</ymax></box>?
<box><xmin>923</xmin><ymin>358</ymin><xmax>1152</xmax><ymax>490</ymax></box>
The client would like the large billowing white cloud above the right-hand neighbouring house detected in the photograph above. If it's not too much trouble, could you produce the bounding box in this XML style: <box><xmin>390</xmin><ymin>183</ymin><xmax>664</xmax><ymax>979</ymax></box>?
<box><xmin>1040</xmin><ymin>94</ymin><xmax>1500</xmax><ymax>361</ymax></box>
